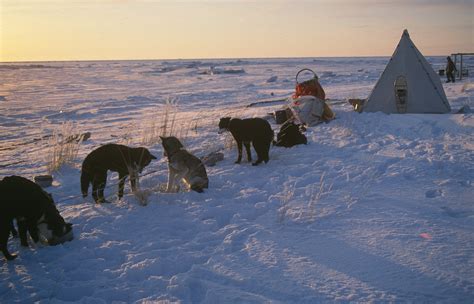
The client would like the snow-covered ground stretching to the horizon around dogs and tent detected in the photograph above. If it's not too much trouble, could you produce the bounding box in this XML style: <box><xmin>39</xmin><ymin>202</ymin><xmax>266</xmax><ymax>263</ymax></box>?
<box><xmin>0</xmin><ymin>57</ymin><xmax>474</xmax><ymax>303</ymax></box>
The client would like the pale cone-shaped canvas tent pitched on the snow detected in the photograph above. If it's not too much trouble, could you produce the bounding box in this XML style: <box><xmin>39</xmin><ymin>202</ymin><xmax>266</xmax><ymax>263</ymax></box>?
<box><xmin>363</xmin><ymin>30</ymin><xmax>451</xmax><ymax>113</ymax></box>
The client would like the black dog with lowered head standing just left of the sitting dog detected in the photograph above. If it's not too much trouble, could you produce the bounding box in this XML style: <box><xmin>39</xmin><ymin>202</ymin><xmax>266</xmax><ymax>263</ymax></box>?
<box><xmin>81</xmin><ymin>144</ymin><xmax>156</xmax><ymax>203</ymax></box>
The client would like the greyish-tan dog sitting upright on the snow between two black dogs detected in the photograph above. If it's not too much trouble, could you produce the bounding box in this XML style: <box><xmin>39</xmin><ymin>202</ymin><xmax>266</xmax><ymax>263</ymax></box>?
<box><xmin>160</xmin><ymin>136</ymin><xmax>209</xmax><ymax>193</ymax></box>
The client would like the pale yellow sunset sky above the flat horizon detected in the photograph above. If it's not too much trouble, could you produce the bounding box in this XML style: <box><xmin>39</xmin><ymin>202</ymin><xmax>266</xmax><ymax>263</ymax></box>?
<box><xmin>0</xmin><ymin>0</ymin><xmax>474</xmax><ymax>62</ymax></box>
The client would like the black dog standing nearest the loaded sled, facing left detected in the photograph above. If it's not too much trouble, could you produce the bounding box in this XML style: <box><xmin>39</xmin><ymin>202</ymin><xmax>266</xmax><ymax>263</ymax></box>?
<box><xmin>219</xmin><ymin>117</ymin><xmax>274</xmax><ymax>166</ymax></box>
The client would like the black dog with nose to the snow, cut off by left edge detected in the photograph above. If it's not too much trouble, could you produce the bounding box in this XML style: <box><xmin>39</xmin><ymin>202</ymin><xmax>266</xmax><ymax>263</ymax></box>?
<box><xmin>0</xmin><ymin>176</ymin><xmax>72</xmax><ymax>260</ymax></box>
